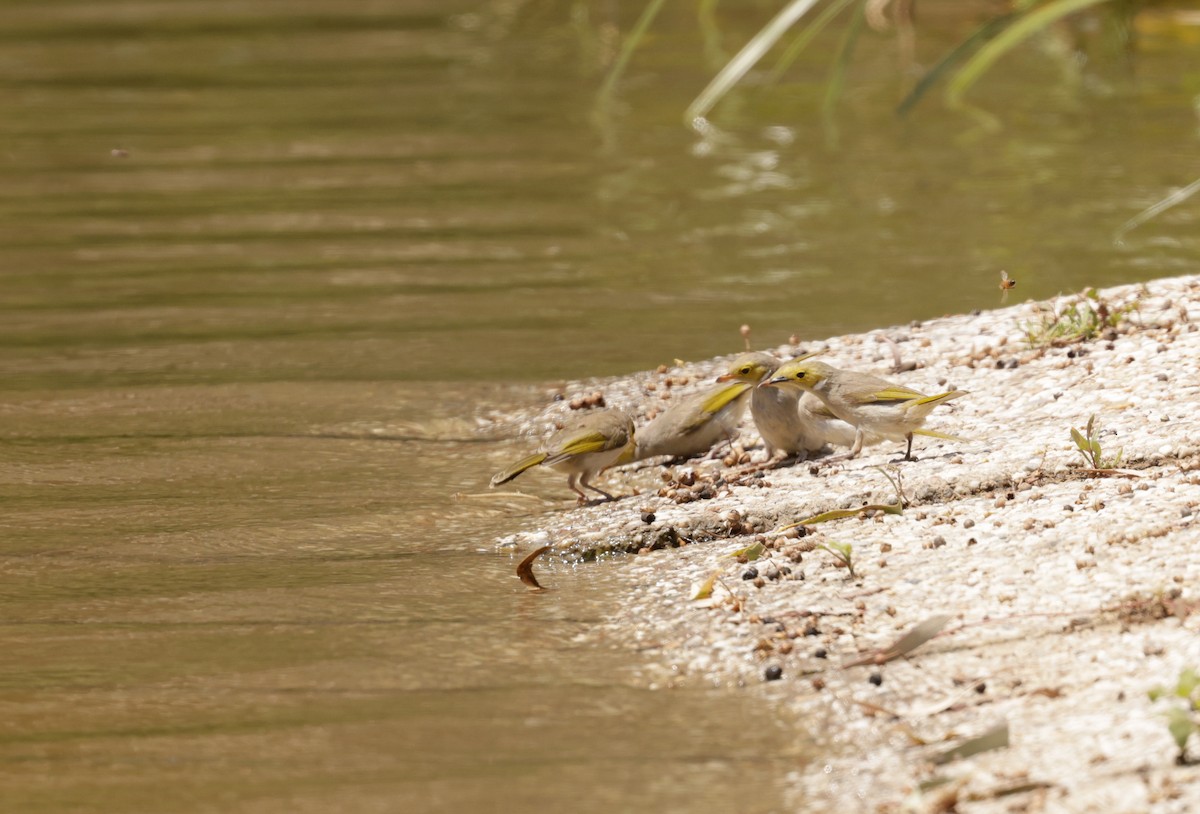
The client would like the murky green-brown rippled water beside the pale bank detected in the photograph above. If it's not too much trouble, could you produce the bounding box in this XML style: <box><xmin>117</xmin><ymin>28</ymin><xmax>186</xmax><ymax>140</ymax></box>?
<box><xmin>0</xmin><ymin>0</ymin><xmax>1200</xmax><ymax>813</ymax></box>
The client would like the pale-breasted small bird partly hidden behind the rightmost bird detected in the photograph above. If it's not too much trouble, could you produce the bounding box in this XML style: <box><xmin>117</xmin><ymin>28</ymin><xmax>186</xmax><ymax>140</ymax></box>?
<box><xmin>716</xmin><ymin>353</ymin><xmax>864</xmax><ymax>460</ymax></box>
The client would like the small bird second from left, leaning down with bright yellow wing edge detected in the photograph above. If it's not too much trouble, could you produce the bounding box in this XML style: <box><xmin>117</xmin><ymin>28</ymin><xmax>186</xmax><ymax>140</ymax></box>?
<box><xmin>619</xmin><ymin>382</ymin><xmax>755</xmax><ymax>463</ymax></box>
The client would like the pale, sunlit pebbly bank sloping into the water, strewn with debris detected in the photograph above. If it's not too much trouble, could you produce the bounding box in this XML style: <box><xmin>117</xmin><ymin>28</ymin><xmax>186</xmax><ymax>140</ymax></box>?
<box><xmin>487</xmin><ymin>276</ymin><xmax>1200</xmax><ymax>812</ymax></box>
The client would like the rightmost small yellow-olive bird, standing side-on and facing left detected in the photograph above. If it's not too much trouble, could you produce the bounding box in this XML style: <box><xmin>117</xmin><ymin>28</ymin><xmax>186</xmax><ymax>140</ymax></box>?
<box><xmin>758</xmin><ymin>360</ymin><xmax>966</xmax><ymax>461</ymax></box>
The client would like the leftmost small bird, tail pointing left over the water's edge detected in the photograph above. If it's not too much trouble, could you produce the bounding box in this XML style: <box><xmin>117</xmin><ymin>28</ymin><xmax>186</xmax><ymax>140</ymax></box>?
<box><xmin>492</xmin><ymin>409</ymin><xmax>635</xmax><ymax>502</ymax></box>
